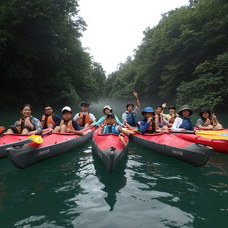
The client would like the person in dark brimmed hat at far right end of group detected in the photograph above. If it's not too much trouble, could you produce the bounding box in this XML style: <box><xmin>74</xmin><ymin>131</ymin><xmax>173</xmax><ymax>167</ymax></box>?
<box><xmin>196</xmin><ymin>108</ymin><xmax>223</xmax><ymax>130</ymax></box>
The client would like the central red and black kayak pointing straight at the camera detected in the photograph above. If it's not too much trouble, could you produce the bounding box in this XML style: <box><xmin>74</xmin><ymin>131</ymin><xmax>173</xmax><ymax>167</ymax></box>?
<box><xmin>92</xmin><ymin>127</ymin><xmax>129</xmax><ymax>172</ymax></box>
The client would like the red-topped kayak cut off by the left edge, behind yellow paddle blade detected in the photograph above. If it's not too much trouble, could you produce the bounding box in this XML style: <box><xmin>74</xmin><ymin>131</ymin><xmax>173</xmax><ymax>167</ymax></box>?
<box><xmin>0</xmin><ymin>134</ymin><xmax>31</xmax><ymax>158</ymax></box>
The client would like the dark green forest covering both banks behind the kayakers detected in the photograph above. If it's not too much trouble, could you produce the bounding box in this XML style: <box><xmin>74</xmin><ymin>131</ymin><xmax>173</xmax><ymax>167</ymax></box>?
<box><xmin>0</xmin><ymin>0</ymin><xmax>228</xmax><ymax>109</ymax></box>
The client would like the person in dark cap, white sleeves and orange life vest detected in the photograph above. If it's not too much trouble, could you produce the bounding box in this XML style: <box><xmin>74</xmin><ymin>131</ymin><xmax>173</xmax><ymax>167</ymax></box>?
<box><xmin>73</xmin><ymin>102</ymin><xmax>96</xmax><ymax>128</ymax></box>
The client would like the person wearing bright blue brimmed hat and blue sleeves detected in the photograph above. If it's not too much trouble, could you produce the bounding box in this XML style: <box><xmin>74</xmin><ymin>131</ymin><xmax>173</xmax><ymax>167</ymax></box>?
<box><xmin>139</xmin><ymin>107</ymin><xmax>159</xmax><ymax>133</ymax></box>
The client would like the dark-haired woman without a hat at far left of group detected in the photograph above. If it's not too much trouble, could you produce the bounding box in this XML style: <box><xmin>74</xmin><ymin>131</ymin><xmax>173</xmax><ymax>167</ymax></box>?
<box><xmin>4</xmin><ymin>104</ymin><xmax>43</xmax><ymax>135</ymax></box>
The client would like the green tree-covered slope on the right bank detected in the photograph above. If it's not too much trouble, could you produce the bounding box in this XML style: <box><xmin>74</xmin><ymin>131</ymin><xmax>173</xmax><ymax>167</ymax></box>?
<box><xmin>106</xmin><ymin>0</ymin><xmax>228</xmax><ymax>109</ymax></box>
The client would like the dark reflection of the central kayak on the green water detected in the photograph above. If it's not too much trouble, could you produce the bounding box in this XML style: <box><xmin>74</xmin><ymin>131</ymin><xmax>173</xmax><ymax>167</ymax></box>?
<box><xmin>93</xmin><ymin>151</ymin><xmax>127</xmax><ymax>211</ymax></box>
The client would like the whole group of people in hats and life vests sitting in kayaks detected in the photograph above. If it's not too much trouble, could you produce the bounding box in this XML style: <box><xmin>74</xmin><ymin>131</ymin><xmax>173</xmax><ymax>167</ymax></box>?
<box><xmin>4</xmin><ymin>91</ymin><xmax>222</xmax><ymax>135</ymax></box>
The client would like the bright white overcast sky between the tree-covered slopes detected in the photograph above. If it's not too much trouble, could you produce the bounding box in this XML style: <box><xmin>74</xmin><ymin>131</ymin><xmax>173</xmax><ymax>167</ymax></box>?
<box><xmin>79</xmin><ymin>0</ymin><xmax>188</xmax><ymax>75</ymax></box>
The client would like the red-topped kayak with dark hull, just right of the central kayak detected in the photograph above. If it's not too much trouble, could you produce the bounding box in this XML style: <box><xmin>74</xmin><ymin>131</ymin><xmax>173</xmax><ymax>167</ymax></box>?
<box><xmin>130</xmin><ymin>132</ymin><xmax>211</xmax><ymax>166</ymax></box>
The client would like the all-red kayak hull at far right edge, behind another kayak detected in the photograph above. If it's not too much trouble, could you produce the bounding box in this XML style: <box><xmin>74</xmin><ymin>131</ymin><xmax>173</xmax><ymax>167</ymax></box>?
<box><xmin>173</xmin><ymin>133</ymin><xmax>228</xmax><ymax>154</ymax></box>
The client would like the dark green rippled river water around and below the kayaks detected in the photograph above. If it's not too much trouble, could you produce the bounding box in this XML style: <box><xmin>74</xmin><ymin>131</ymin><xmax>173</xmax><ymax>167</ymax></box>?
<box><xmin>0</xmin><ymin>106</ymin><xmax>228</xmax><ymax>228</ymax></box>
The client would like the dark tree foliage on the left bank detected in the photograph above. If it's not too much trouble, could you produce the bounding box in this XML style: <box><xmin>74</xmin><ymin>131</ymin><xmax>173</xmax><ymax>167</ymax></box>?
<box><xmin>0</xmin><ymin>0</ymin><xmax>104</xmax><ymax>106</ymax></box>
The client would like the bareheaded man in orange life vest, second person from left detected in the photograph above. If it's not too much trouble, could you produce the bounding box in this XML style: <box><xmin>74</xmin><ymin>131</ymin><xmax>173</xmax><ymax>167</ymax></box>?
<box><xmin>41</xmin><ymin>105</ymin><xmax>61</xmax><ymax>129</ymax></box>
